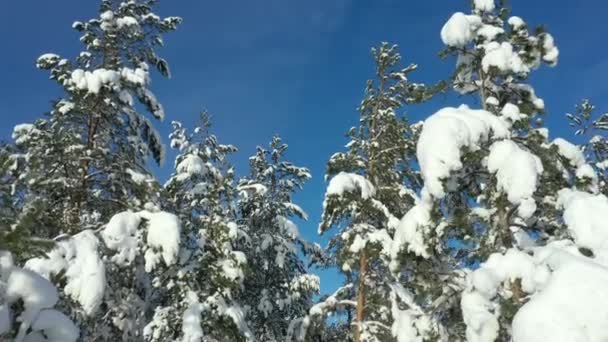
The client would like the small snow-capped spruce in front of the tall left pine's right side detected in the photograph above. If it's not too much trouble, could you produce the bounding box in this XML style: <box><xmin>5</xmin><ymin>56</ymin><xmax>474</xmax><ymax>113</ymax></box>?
<box><xmin>101</xmin><ymin>204</ymin><xmax>184</xmax><ymax>341</ymax></box>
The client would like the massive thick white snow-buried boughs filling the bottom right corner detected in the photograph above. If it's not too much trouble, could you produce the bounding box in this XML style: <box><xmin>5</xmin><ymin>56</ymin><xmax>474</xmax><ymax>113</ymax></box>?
<box><xmin>462</xmin><ymin>189</ymin><xmax>608</xmax><ymax>342</ymax></box>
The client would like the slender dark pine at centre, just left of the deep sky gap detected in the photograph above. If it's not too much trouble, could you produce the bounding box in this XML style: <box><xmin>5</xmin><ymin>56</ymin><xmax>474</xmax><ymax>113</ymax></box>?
<box><xmin>238</xmin><ymin>136</ymin><xmax>320</xmax><ymax>341</ymax></box>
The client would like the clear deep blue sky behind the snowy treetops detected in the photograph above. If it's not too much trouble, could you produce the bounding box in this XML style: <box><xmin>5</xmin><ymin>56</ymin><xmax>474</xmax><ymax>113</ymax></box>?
<box><xmin>0</xmin><ymin>0</ymin><xmax>608</xmax><ymax>290</ymax></box>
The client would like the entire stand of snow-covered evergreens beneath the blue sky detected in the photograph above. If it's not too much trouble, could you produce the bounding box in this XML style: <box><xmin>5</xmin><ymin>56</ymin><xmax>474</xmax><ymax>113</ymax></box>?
<box><xmin>0</xmin><ymin>0</ymin><xmax>608</xmax><ymax>342</ymax></box>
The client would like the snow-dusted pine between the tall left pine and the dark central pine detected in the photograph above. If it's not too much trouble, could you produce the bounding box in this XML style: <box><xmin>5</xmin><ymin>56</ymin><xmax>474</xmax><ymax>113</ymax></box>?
<box><xmin>158</xmin><ymin>113</ymin><xmax>253</xmax><ymax>342</ymax></box>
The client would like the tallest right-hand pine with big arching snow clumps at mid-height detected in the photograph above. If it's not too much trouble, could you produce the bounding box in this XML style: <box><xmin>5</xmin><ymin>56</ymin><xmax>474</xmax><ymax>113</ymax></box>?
<box><xmin>411</xmin><ymin>0</ymin><xmax>565</xmax><ymax>338</ymax></box>
